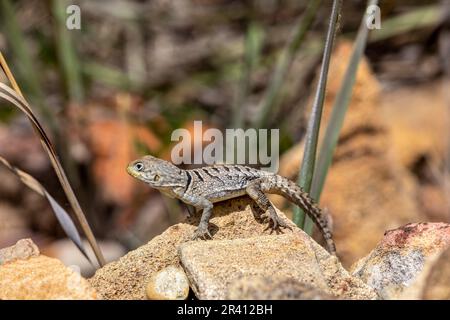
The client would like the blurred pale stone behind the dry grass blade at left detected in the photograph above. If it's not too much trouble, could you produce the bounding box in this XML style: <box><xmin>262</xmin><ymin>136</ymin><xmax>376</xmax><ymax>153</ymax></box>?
<box><xmin>42</xmin><ymin>239</ymin><xmax>126</xmax><ymax>277</ymax></box>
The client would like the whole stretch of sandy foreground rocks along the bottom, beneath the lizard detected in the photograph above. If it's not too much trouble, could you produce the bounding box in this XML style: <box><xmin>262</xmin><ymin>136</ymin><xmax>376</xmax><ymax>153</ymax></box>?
<box><xmin>0</xmin><ymin>197</ymin><xmax>450</xmax><ymax>299</ymax></box>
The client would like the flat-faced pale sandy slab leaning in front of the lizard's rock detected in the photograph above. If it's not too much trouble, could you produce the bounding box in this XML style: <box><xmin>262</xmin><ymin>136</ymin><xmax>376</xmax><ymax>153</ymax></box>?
<box><xmin>179</xmin><ymin>229</ymin><xmax>376</xmax><ymax>299</ymax></box>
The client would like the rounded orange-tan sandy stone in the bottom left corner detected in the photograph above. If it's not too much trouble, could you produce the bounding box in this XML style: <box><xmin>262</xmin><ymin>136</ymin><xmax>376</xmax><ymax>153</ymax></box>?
<box><xmin>0</xmin><ymin>255</ymin><xmax>97</xmax><ymax>300</ymax></box>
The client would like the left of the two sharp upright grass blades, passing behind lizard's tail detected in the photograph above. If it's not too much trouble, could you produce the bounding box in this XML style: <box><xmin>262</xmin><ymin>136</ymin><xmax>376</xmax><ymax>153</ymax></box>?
<box><xmin>293</xmin><ymin>0</ymin><xmax>342</xmax><ymax>234</ymax></box>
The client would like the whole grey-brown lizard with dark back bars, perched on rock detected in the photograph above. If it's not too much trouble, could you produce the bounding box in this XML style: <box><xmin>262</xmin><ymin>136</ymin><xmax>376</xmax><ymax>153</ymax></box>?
<box><xmin>127</xmin><ymin>155</ymin><xmax>336</xmax><ymax>254</ymax></box>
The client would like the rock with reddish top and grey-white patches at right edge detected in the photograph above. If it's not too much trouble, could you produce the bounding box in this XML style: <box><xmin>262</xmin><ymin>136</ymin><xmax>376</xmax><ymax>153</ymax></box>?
<box><xmin>351</xmin><ymin>223</ymin><xmax>450</xmax><ymax>299</ymax></box>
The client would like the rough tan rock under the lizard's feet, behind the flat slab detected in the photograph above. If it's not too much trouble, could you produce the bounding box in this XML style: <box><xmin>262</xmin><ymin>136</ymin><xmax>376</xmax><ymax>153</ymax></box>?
<box><xmin>89</xmin><ymin>197</ymin><xmax>364</xmax><ymax>299</ymax></box>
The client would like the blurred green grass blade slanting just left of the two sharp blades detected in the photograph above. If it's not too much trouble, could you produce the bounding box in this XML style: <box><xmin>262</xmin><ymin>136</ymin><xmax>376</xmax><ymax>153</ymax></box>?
<box><xmin>254</xmin><ymin>0</ymin><xmax>322</xmax><ymax>128</ymax></box>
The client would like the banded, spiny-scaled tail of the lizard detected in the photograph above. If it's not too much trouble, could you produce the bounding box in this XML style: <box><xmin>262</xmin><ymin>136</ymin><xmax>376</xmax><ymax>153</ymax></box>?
<box><xmin>267</xmin><ymin>175</ymin><xmax>336</xmax><ymax>255</ymax></box>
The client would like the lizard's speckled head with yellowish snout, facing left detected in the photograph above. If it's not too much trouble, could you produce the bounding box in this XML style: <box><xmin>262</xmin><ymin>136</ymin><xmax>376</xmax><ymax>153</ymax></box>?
<box><xmin>127</xmin><ymin>156</ymin><xmax>187</xmax><ymax>188</ymax></box>
